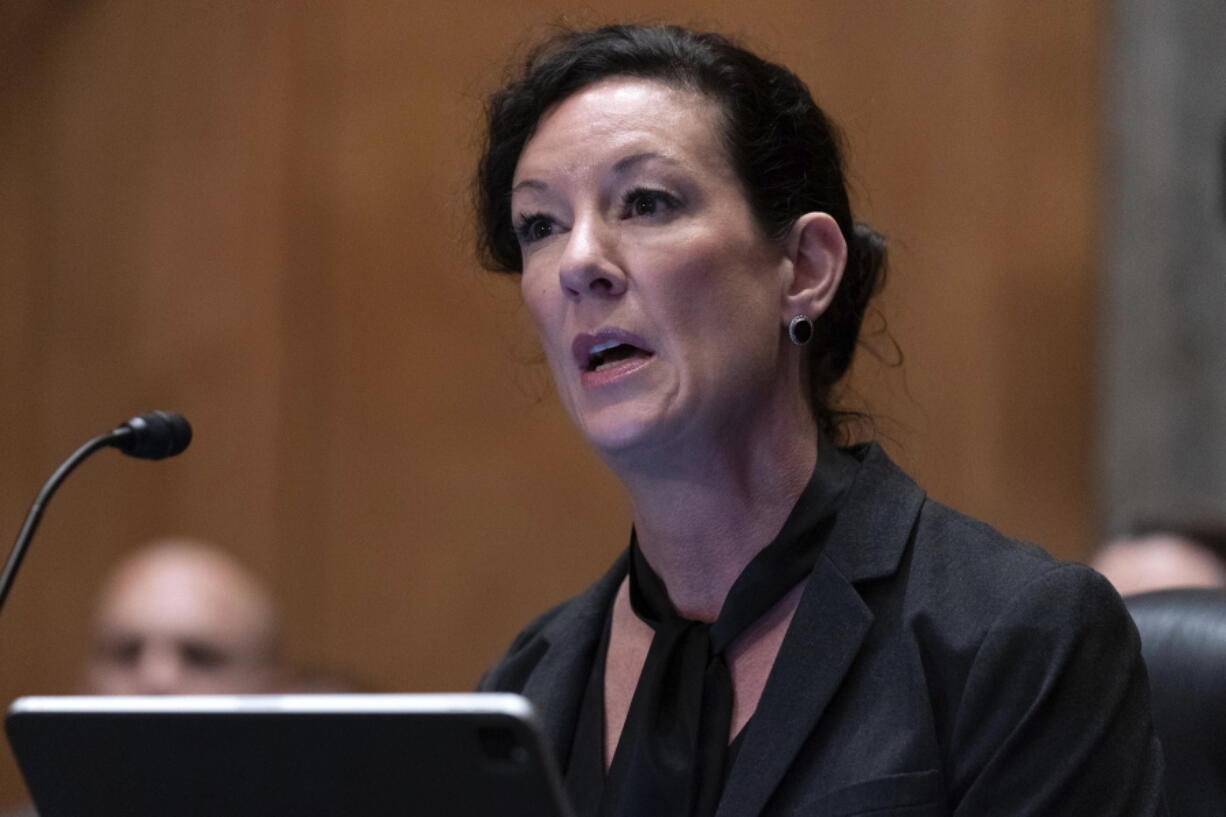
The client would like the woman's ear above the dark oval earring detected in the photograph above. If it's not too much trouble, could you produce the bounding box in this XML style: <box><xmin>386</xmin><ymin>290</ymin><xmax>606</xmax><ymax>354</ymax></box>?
<box><xmin>780</xmin><ymin>212</ymin><xmax>847</xmax><ymax>326</ymax></box>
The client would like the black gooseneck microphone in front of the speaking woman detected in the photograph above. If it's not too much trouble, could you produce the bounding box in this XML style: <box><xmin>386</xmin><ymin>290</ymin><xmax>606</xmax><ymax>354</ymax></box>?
<box><xmin>0</xmin><ymin>411</ymin><xmax>191</xmax><ymax>610</ymax></box>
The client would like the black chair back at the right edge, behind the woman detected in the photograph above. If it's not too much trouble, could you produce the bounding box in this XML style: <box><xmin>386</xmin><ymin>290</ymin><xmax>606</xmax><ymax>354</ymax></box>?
<box><xmin>1124</xmin><ymin>588</ymin><xmax>1226</xmax><ymax>817</ymax></box>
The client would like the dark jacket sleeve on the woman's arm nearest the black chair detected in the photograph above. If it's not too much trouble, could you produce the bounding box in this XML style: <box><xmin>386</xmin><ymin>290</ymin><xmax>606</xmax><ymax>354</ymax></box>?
<box><xmin>905</xmin><ymin>502</ymin><xmax>1161</xmax><ymax>813</ymax></box>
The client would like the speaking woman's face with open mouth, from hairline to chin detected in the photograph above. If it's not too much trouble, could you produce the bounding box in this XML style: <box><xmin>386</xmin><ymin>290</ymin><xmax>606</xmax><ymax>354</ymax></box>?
<box><xmin>511</xmin><ymin>79</ymin><xmax>788</xmax><ymax>458</ymax></box>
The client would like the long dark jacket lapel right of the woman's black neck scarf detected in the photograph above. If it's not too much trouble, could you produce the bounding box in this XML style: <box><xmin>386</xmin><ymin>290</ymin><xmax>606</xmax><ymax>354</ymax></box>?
<box><xmin>716</xmin><ymin>444</ymin><xmax>924</xmax><ymax>817</ymax></box>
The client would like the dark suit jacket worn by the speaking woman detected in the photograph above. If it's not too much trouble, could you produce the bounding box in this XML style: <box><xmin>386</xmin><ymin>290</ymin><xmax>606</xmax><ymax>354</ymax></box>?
<box><xmin>482</xmin><ymin>445</ymin><xmax>1165</xmax><ymax>817</ymax></box>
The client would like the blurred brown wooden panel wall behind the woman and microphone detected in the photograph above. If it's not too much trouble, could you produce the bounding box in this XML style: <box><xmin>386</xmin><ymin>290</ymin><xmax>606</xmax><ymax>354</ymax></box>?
<box><xmin>0</xmin><ymin>0</ymin><xmax>1101</xmax><ymax>806</ymax></box>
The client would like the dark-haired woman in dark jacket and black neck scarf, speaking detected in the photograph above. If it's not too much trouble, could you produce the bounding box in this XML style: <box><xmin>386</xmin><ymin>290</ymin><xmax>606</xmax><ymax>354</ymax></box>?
<box><xmin>478</xmin><ymin>26</ymin><xmax>1161</xmax><ymax>817</ymax></box>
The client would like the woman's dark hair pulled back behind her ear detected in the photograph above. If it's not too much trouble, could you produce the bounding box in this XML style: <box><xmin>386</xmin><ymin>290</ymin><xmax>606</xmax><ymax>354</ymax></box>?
<box><xmin>476</xmin><ymin>26</ymin><xmax>885</xmax><ymax>433</ymax></box>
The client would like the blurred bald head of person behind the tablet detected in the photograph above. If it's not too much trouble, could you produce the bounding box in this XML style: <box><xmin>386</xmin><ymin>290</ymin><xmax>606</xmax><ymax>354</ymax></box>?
<box><xmin>86</xmin><ymin>540</ymin><xmax>278</xmax><ymax>694</ymax></box>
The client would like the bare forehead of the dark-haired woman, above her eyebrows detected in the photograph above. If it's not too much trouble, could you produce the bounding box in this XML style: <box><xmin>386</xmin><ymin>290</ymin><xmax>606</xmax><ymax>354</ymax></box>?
<box><xmin>515</xmin><ymin>77</ymin><xmax>729</xmax><ymax>184</ymax></box>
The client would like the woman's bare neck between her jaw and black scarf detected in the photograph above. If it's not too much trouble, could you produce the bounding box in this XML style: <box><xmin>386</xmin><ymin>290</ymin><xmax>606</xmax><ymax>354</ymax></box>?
<box><xmin>619</xmin><ymin>399</ymin><xmax>818</xmax><ymax>621</ymax></box>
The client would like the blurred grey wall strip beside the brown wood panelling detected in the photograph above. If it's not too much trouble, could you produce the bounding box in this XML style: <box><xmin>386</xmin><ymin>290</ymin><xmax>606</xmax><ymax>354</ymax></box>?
<box><xmin>1101</xmin><ymin>0</ymin><xmax>1226</xmax><ymax>530</ymax></box>
